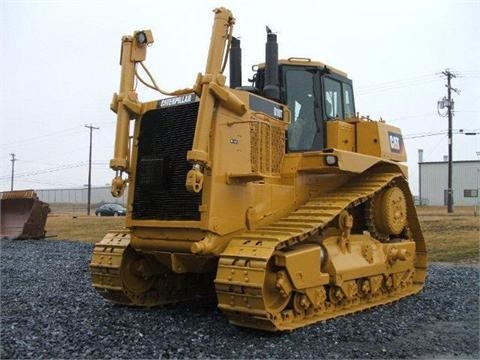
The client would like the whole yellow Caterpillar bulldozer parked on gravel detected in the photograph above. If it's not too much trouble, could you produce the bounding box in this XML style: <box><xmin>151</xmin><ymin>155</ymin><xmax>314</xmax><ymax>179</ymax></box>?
<box><xmin>90</xmin><ymin>8</ymin><xmax>426</xmax><ymax>331</ymax></box>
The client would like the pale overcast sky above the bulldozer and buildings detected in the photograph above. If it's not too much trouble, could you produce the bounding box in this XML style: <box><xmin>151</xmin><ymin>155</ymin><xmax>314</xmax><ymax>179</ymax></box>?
<box><xmin>0</xmin><ymin>0</ymin><xmax>480</xmax><ymax>193</ymax></box>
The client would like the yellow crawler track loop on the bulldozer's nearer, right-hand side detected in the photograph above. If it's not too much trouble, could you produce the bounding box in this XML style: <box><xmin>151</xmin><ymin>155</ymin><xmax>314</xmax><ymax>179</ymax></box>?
<box><xmin>215</xmin><ymin>173</ymin><xmax>426</xmax><ymax>331</ymax></box>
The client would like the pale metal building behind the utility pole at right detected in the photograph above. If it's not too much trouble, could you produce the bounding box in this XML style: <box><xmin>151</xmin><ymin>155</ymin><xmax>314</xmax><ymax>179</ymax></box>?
<box><xmin>418</xmin><ymin>159</ymin><xmax>480</xmax><ymax>206</ymax></box>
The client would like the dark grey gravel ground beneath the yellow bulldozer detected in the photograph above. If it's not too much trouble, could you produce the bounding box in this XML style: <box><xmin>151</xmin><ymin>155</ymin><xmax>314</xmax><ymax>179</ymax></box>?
<box><xmin>0</xmin><ymin>240</ymin><xmax>480</xmax><ymax>359</ymax></box>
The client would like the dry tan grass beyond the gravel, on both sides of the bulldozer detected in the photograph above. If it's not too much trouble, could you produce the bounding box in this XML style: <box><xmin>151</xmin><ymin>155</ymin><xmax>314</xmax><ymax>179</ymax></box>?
<box><xmin>46</xmin><ymin>206</ymin><xmax>480</xmax><ymax>264</ymax></box>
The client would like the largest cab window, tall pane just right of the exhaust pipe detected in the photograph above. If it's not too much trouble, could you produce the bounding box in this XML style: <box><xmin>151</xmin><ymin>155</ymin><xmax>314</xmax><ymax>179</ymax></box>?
<box><xmin>285</xmin><ymin>69</ymin><xmax>317</xmax><ymax>151</ymax></box>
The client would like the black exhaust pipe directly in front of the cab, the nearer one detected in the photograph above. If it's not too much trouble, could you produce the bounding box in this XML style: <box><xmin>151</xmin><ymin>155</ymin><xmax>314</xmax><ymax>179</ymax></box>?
<box><xmin>263</xmin><ymin>26</ymin><xmax>280</xmax><ymax>100</ymax></box>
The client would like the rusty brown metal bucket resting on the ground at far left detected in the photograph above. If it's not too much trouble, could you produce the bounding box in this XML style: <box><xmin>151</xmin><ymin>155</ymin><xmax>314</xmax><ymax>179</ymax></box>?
<box><xmin>0</xmin><ymin>190</ymin><xmax>50</xmax><ymax>240</ymax></box>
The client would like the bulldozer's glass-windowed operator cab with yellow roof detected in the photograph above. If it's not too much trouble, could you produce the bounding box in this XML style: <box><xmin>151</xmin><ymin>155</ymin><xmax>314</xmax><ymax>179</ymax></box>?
<box><xmin>254</xmin><ymin>58</ymin><xmax>355</xmax><ymax>152</ymax></box>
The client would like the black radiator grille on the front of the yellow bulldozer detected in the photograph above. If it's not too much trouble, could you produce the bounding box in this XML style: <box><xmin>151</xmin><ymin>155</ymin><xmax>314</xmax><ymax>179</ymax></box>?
<box><xmin>132</xmin><ymin>102</ymin><xmax>201</xmax><ymax>220</ymax></box>
